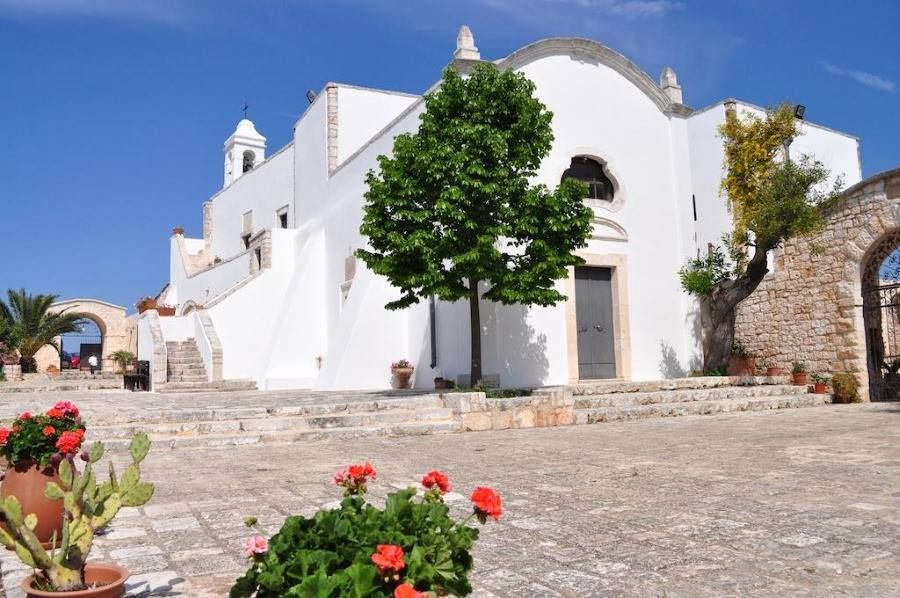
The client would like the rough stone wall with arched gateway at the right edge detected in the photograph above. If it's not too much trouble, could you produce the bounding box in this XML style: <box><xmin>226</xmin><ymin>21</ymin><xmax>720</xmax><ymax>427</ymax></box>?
<box><xmin>737</xmin><ymin>168</ymin><xmax>900</xmax><ymax>400</ymax></box>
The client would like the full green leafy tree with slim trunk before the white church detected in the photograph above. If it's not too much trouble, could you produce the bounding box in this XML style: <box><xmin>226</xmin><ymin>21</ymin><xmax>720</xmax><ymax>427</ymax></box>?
<box><xmin>357</xmin><ymin>64</ymin><xmax>592</xmax><ymax>385</ymax></box>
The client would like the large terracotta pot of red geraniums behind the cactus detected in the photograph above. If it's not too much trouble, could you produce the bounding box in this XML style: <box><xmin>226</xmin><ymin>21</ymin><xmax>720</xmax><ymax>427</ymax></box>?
<box><xmin>0</xmin><ymin>461</ymin><xmax>65</xmax><ymax>544</ymax></box>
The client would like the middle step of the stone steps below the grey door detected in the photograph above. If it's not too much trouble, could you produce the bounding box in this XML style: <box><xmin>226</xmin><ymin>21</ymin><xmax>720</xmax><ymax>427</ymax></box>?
<box><xmin>575</xmin><ymin>384</ymin><xmax>807</xmax><ymax>409</ymax></box>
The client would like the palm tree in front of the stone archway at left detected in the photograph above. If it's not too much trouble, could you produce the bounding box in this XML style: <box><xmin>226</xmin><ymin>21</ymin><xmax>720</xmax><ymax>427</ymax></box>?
<box><xmin>0</xmin><ymin>289</ymin><xmax>86</xmax><ymax>372</ymax></box>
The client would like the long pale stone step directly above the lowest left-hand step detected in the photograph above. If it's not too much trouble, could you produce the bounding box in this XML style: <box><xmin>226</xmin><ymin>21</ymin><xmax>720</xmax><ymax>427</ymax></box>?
<box><xmin>91</xmin><ymin>408</ymin><xmax>453</xmax><ymax>439</ymax></box>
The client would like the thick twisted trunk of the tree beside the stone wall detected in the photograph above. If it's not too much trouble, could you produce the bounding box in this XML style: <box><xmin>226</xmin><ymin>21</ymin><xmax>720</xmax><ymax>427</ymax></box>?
<box><xmin>700</xmin><ymin>247</ymin><xmax>769</xmax><ymax>372</ymax></box>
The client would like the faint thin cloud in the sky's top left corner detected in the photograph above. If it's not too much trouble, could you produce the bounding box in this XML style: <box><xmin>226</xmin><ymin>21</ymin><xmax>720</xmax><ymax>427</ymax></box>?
<box><xmin>0</xmin><ymin>0</ymin><xmax>187</xmax><ymax>25</ymax></box>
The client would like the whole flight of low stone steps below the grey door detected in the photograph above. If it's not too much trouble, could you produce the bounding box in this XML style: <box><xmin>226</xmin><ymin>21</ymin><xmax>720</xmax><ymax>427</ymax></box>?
<box><xmin>572</xmin><ymin>377</ymin><xmax>831</xmax><ymax>424</ymax></box>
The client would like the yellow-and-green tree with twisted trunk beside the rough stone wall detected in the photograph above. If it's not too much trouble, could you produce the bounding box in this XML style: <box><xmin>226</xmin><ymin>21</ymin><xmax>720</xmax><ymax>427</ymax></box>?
<box><xmin>679</xmin><ymin>105</ymin><xmax>841</xmax><ymax>370</ymax></box>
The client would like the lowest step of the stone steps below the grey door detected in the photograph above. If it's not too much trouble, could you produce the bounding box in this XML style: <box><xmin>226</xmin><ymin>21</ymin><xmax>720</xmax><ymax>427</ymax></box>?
<box><xmin>575</xmin><ymin>393</ymin><xmax>831</xmax><ymax>424</ymax></box>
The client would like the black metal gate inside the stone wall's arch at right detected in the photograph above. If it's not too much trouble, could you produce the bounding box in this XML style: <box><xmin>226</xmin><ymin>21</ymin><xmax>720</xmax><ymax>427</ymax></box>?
<box><xmin>863</xmin><ymin>283</ymin><xmax>900</xmax><ymax>401</ymax></box>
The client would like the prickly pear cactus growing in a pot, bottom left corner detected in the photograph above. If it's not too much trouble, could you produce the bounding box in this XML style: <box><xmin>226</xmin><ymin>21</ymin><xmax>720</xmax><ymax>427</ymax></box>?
<box><xmin>0</xmin><ymin>432</ymin><xmax>153</xmax><ymax>591</ymax></box>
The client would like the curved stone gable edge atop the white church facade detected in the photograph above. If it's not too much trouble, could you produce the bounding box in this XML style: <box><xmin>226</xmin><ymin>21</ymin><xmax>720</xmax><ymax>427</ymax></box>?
<box><xmin>496</xmin><ymin>37</ymin><xmax>691</xmax><ymax>114</ymax></box>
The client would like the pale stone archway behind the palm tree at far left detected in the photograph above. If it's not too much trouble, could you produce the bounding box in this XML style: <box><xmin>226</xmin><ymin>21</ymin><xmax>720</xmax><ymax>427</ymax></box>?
<box><xmin>35</xmin><ymin>299</ymin><xmax>137</xmax><ymax>372</ymax></box>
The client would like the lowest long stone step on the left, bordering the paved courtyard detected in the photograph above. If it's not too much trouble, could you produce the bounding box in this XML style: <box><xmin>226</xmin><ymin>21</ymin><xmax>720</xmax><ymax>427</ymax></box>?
<box><xmin>103</xmin><ymin>421</ymin><xmax>459</xmax><ymax>450</ymax></box>
